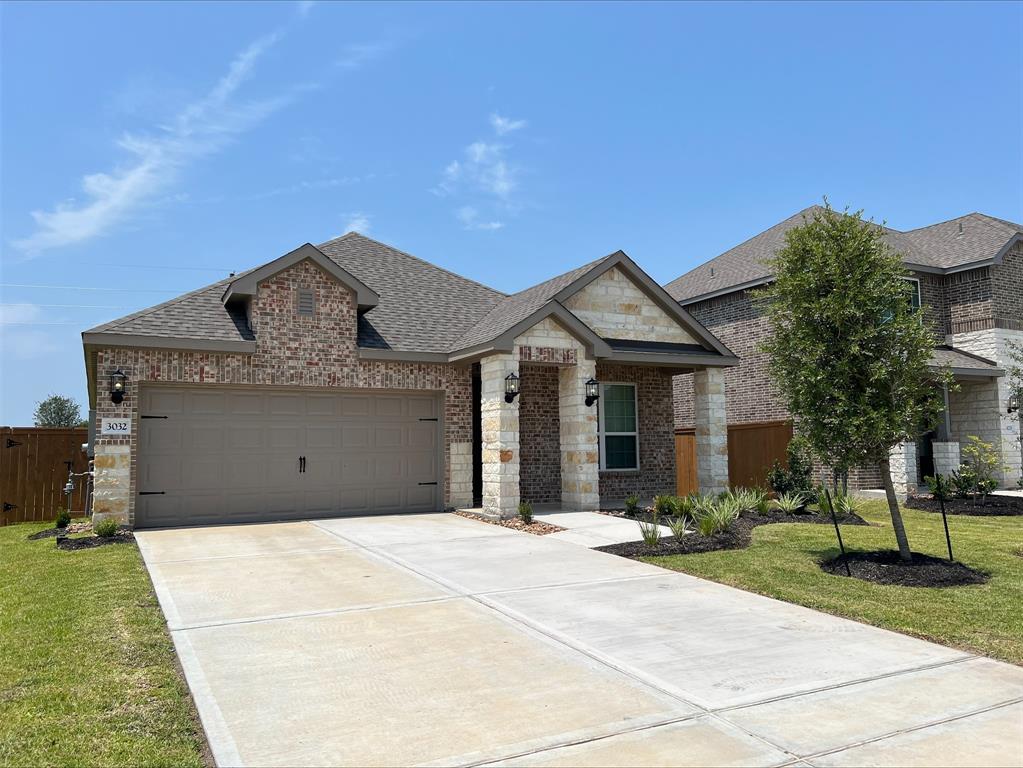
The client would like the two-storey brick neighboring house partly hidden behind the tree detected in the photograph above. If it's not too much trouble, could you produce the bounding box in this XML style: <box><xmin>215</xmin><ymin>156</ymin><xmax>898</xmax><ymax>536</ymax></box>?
<box><xmin>665</xmin><ymin>207</ymin><xmax>1023</xmax><ymax>493</ymax></box>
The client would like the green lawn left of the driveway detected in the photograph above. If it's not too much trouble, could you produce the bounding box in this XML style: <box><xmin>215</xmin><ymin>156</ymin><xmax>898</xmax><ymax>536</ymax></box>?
<box><xmin>0</xmin><ymin>524</ymin><xmax>205</xmax><ymax>766</ymax></box>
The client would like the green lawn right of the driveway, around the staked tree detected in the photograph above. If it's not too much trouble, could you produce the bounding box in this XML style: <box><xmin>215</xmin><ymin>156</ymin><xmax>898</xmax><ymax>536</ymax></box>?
<box><xmin>643</xmin><ymin>501</ymin><xmax>1023</xmax><ymax>664</ymax></box>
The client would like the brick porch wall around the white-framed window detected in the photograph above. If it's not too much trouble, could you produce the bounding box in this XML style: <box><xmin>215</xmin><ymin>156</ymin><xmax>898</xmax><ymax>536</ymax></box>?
<box><xmin>596</xmin><ymin>363</ymin><xmax>675</xmax><ymax>500</ymax></box>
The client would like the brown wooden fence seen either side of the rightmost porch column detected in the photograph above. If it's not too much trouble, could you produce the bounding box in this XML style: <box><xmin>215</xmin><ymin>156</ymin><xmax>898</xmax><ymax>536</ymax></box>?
<box><xmin>675</xmin><ymin>421</ymin><xmax>792</xmax><ymax>496</ymax></box>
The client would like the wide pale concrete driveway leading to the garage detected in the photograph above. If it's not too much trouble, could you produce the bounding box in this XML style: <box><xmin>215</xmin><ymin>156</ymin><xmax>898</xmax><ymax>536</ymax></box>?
<box><xmin>136</xmin><ymin>514</ymin><xmax>1023</xmax><ymax>766</ymax></box>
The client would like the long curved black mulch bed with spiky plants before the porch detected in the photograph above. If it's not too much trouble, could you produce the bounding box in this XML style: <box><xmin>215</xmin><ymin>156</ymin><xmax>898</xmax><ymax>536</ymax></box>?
<box><xmin>595</xmin><ymin>509</ymin><xmax>870</xmax><ymax>557</ymax></box>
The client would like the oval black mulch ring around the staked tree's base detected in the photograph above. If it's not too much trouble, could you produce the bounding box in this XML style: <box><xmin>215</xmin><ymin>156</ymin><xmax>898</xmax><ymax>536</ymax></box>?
<box><xmin>820</xmin><ymin>550</ymin><xmax>990</xmax><ymax>587</ymax></box>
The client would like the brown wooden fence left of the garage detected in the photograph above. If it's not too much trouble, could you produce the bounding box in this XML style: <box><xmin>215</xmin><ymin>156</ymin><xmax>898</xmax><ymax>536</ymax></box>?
<box><xmin>0</xmin><ymin>426</ymin><xmax>89</xmax><ymax>526</ymax></box>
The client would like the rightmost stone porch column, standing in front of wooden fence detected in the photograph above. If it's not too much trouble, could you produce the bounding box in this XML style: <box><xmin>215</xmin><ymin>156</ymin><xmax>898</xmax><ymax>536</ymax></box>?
<box><xmin>693</xmin><ymin>368</ymin><xmax>728</xmax><ymax>494</ymax></box>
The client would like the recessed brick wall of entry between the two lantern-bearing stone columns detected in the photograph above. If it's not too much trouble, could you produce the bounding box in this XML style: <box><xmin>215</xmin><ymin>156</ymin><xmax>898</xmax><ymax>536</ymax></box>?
<box><xmin>519</xmin><ymin>364</ymin><xmax>575</xmax><ymax>504</ymax></box>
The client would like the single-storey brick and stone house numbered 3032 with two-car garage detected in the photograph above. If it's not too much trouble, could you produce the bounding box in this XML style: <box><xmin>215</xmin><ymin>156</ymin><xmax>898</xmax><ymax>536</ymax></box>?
<box><xmin>82</xmin><ymin>233</ymin><xmax>738</xmax><ymax>527</ymax></box>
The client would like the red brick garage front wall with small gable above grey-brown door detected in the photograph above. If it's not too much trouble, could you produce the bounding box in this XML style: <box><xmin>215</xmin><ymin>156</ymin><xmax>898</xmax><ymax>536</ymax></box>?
<box><xmin>96</xmin><ymin>262</ymin><xmax>473</xmax><ymax>519</ymax></box>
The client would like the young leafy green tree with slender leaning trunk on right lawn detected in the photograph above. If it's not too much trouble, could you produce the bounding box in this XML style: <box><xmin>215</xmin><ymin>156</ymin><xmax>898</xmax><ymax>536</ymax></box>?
<box><xmin>760</xmin><ymin>199</ymin><xmax>948</xmax><ymax>560</ymax></box>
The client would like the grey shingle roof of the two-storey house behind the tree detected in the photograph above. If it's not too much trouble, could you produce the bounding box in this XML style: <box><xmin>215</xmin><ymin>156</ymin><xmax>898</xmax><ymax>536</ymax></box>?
<box><xmin>665</xmin><ymin>206</ymin><xmax>1023</xmax><ymax>304</ymax></box>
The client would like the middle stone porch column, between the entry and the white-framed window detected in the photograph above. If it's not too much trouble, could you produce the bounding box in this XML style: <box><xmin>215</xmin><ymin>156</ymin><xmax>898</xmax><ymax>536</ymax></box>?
<box><xmin>558</xmin><ymin>360</ymin><xmax>597</xmax><ymax>511</ymax></box>
